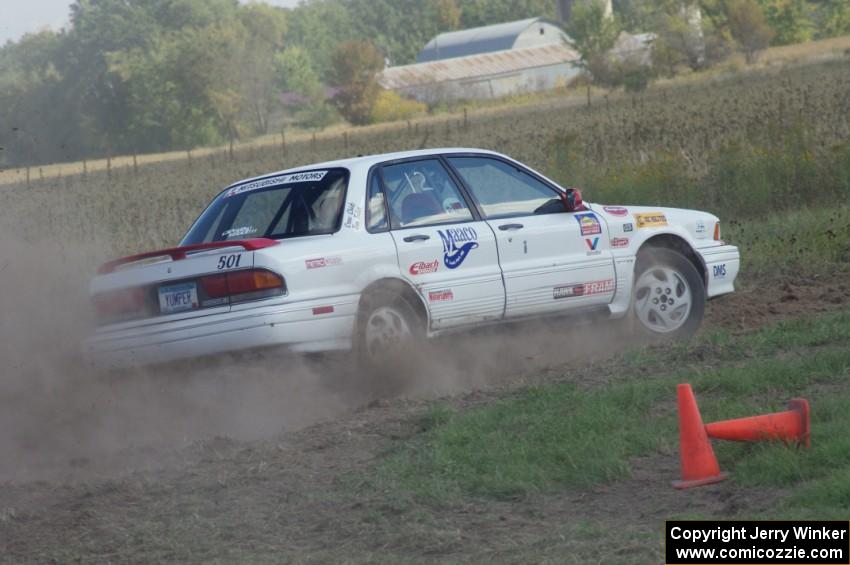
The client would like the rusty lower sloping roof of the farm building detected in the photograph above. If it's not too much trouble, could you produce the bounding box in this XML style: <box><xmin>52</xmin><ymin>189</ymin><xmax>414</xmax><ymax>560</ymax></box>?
<box><xmin>379</xmin><ymin>43</ymin><xmax>579</xmax><ymax>90</ymax></box>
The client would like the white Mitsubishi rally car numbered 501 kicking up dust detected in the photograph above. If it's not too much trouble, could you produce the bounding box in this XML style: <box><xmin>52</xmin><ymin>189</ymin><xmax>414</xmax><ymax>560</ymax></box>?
<box><xmin>84</xmin><ymin>149</ymin><xmax>739</xmax><ymax>367</ymax></box>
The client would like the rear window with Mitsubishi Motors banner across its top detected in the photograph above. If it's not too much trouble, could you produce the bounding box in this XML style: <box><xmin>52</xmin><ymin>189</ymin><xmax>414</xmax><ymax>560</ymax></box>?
<box><xmin>180</xmin><ymin>169</ymin><xmax>348</xmax><ymax>245</ymax></box>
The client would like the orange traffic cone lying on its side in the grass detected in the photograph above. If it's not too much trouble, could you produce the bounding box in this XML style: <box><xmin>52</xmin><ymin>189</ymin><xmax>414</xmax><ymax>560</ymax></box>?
<box><xmin>705</xmin><ymin>398</ymin><xmax>811</xmax><ymax>447</ymax></box>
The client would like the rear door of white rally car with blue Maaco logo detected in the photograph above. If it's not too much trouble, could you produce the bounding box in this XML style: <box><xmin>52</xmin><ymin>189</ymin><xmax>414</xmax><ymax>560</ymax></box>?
<box><xmin>376</xmin><ymin>157</ymin><xmax>505</xmax><ymax>330</ymax></box>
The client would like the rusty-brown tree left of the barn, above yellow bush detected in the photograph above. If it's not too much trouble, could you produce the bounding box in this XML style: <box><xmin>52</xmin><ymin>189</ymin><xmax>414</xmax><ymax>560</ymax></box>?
<box><xmin>333</xmin><ymin>41</ymin><xmax>384</xmax><ymax>125</ymax></box>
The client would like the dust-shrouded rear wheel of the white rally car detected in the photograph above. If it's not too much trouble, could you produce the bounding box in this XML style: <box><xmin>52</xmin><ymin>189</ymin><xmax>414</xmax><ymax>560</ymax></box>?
<box><xmin>355</xmin><ymin>290</ymin><xmax>425</xmax><ymax>380</ymax></box>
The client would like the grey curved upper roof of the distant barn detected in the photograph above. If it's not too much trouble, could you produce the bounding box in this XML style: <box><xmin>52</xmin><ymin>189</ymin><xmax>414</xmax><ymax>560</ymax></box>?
<box><xmin>416</xmin><ymin>18</ymin><xmax>557</xmax><ymax>63</ymax></box>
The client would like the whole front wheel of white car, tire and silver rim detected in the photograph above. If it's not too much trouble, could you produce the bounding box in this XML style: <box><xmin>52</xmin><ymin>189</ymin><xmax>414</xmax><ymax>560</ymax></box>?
<box><xmin>628</xmin><ymin>248</ymin><xmax>706</xmax><ymax>343</ymax></box>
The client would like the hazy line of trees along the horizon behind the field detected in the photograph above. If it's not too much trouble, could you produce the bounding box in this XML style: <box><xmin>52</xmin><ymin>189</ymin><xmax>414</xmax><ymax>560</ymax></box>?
<box><xmin>0</xmin><ymin>0</ymin><xmax>850</xmax><ymax>167</ymax></box>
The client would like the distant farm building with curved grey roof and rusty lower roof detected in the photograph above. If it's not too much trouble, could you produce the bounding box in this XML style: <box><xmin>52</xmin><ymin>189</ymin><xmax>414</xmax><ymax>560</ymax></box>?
<box><xmin>379</xmin><ymin>18</ymin><xmax>579</xmax><ymax>103</ymax></box>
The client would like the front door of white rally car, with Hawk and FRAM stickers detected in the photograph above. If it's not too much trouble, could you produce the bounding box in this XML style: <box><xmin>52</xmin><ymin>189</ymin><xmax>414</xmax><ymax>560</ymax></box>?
<box><xmin>446</xmin><ymin>155</ymin><xmax>616</xmax><ymax>317</ymax></box>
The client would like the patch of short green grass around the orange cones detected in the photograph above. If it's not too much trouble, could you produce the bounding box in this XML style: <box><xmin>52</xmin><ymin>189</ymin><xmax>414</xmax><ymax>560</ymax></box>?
<box><xmin>368</xmin><ymin>311</ymin><xmax>850</xmax><ymax>518</ymax></box>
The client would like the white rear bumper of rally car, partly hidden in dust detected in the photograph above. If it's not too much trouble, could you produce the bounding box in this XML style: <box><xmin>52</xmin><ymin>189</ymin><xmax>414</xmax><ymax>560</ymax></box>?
<box><xmin>82</xmin><ymin>297</ymin><xmax>357</xmax><ymax>369</ymax></box>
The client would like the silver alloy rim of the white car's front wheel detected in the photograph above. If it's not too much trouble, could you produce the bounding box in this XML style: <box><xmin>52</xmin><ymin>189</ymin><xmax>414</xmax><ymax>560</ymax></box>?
<box><xmin>634</xmin><ymin>266</ymin><xmax>693</xmax><ymax>333</ymax></box>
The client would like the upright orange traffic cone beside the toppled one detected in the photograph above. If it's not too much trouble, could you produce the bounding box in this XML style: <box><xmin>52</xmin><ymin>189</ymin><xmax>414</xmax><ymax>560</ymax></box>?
<box><xmin>673</xmin><ymin>384</ymin><xmax>728</xmax><ymax>489</ymax></box>
